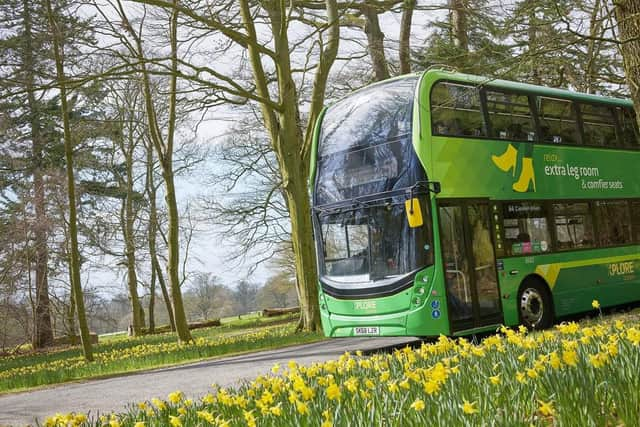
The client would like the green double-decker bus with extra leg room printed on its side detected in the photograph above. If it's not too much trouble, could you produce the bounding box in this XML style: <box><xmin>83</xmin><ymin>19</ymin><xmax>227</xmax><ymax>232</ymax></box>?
<box><xmin>310</xmin><ymin>70</ymin><xmax>640</xmax><ymax>337</ymax></box>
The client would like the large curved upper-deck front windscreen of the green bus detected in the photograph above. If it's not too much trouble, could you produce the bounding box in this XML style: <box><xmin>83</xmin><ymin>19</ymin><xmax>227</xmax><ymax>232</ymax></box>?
<box><xmin>315</xmin><ymin>77</ymin><xmax>424</xmax><ymax>205</ymax></box>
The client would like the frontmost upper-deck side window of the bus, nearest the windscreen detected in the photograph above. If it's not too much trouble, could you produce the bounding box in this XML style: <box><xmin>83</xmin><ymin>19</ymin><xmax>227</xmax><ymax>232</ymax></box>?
<box><xmin>431</xmin><ymin>82</ymin><xmax>486</xmax><ymax>136</ymax></box>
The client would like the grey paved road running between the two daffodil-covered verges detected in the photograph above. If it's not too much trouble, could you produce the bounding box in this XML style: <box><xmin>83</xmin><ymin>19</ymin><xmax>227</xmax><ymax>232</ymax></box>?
<box><xmin>0</xmin><ymin>338</ymin><xmax>415</xmax><ymax>426</ymax></box>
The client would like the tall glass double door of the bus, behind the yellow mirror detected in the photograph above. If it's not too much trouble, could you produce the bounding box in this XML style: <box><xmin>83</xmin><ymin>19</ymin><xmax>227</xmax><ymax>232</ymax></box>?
<box><xmin>438</xmin><ymin>201</ymin><xmax>503</xmax><ymax>332</ymax></box>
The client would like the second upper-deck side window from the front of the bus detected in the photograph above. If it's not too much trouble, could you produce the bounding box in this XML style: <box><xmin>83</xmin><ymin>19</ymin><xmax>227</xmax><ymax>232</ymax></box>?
<box><xmin>487</xmin><ymin>90</ymin><xmax>536</xmax><ymax>141</ymax></box>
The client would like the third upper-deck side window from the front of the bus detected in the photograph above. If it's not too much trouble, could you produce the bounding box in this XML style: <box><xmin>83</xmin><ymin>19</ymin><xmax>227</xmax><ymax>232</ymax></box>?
<box><xmin>538</xmin><ymin>97</ymin><xmax>580</xmax><ymax>144</ymax></box>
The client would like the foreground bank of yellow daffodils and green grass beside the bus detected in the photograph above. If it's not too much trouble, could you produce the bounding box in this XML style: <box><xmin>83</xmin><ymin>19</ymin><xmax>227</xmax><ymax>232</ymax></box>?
<box><xmin>42</xmin><ymin>310</ymin><xmax>640</xmax><ymax>427</ymax></box>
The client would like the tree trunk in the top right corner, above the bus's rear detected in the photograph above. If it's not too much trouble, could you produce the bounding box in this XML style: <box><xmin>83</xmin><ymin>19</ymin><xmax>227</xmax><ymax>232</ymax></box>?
<box><xmin>613</xmin><ymin>0</ymin><xmax>640</xmax><ymax>124</ymax></box>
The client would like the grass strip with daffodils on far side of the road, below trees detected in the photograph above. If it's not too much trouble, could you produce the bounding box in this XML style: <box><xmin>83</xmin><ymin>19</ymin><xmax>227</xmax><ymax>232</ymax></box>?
<box><xmin>0</xmin><ymin>316</ymin><xmax>322</xmax><ymax>392</ymax></box>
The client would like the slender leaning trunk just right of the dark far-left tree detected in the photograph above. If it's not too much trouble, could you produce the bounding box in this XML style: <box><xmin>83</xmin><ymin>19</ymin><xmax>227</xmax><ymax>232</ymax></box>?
<box><xmin>45</xmin><ymin>0</ymin><xmax>93</xmax><ymax>361</ymax></box>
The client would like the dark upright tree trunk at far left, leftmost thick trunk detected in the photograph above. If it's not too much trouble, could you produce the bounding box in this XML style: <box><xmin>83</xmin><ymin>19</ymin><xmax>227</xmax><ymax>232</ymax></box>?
<box><xmin>22</xmin><ymin>0</ymin><xmax>53</xmax><ymax>348</ymax></box>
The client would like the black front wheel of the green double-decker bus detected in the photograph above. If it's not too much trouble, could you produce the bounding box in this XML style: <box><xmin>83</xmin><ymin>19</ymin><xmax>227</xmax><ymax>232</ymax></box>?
<box><xmin>518</xmin><ymin>280</ymin><xmax>553</xmax><ymax>329</ymax></box>
